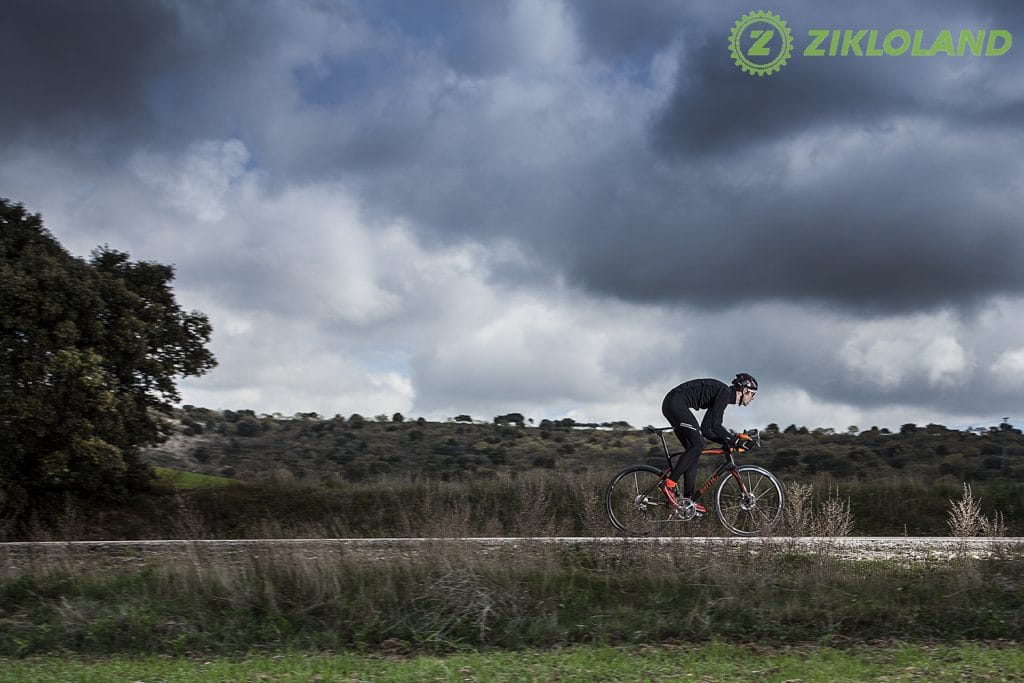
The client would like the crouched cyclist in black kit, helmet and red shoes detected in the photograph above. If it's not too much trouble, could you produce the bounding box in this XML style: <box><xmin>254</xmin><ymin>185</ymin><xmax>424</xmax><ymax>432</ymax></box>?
<box><xmin>662</xmin><ymin>373</ymin><xmax>758</xmax><ymax>515</ymax></box>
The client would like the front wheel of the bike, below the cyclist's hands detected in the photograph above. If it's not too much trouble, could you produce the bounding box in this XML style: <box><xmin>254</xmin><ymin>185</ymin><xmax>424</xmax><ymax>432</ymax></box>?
<box><xmin>715</xmin><ymin>465</ymin><xmax>784</xmax><ymax>536</ymax></box>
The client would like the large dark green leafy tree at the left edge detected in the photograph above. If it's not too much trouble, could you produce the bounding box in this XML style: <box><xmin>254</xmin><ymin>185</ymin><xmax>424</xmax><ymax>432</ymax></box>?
<box><xmin>0</xmin><ymin>199</ymin><xmax>216</xmax><ymax>523</ymax></box>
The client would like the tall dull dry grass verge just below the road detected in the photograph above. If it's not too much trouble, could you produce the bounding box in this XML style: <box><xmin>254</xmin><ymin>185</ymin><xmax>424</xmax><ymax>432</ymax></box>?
<box><xmin>0</xmin><ymin>543</ymin><xmax>1024</xmax><ymax>656</ymax></box>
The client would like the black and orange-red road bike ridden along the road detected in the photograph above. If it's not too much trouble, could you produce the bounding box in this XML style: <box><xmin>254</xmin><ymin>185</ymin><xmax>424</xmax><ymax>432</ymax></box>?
<box><xmin>604</xmin><ymin>426</ymin><xmax>784</xmax><ymax>536</ymax></box>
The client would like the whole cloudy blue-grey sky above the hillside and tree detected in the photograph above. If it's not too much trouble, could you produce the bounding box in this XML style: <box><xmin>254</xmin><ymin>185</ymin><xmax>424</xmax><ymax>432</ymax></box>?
<box><xmin>0</xmin><ymin>0</ymin><xmax>1024</xmax><ymax>430</ymax></box>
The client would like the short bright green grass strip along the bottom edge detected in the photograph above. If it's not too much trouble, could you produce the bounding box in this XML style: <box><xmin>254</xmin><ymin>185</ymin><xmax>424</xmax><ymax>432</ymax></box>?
<box><xmin>0</xmin><ymin>642</ymin><xmax>1024</xmax><ymax>683</ymax></box>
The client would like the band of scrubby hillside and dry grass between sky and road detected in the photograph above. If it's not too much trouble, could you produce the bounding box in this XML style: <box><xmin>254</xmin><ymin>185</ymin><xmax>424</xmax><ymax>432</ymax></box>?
<box><xmin>64</xmin><ymin>407</ymin><xmax>1024</xmax><ymax>539</ymax></box>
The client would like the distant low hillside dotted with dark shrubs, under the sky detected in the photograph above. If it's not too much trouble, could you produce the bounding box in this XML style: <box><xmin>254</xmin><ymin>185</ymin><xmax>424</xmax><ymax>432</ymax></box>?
<box><xmin>143</xmin><ymin>405</ymin><xmax>1024</xmax><ymax>482</ymax></box>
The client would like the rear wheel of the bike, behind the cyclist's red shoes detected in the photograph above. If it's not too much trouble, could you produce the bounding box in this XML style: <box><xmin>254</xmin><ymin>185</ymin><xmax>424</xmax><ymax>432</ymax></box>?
<box><xmin>604</xmin><ymin>465</ymin><xmax>680</xmax><ymax>536</ymax></box>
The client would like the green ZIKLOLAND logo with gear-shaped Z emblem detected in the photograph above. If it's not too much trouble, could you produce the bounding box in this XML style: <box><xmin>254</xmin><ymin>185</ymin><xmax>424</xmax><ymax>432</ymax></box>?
<box><xmin>729</xmin><ymin>9</ymin><xmax>1014</xmax><ymax>76</ymax></box>
